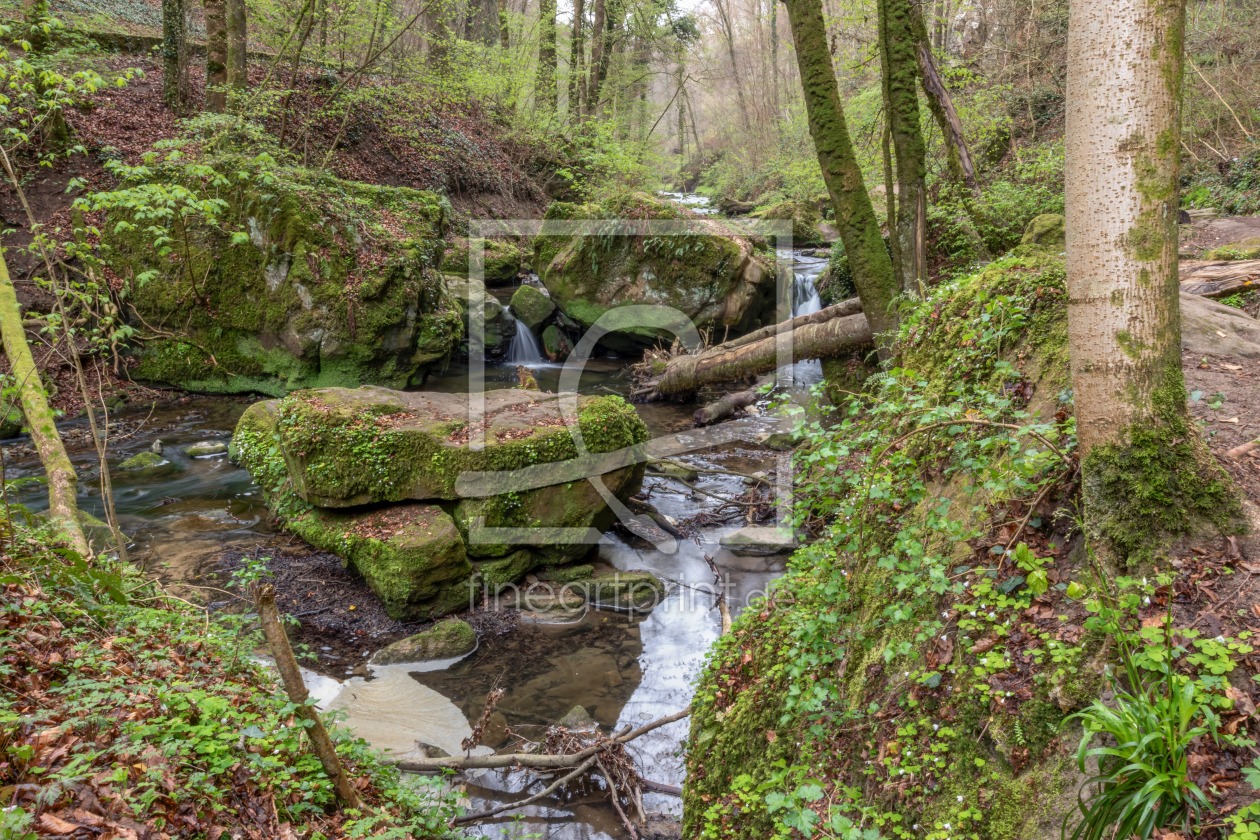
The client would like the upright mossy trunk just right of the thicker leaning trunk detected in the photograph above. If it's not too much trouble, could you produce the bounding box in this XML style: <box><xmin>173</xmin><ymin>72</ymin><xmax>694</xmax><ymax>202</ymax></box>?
<box><xmin>878</xmin><ymin>0</ymin><xmax>927</xmax><ymax>295</ymax></box>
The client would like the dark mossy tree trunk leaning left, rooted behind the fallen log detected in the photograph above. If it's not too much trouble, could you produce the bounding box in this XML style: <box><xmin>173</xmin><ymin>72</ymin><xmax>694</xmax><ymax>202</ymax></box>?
<box><xmin>784</xmin><ymin>0</ymin><xmax>897</xmax><ymax>356</ymax></box>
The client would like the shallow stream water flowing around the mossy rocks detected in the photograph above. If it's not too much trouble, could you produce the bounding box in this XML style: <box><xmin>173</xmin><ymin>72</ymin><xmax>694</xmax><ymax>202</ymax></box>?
<box><xmin>5</xmin><ymin>238</ymin><xmax>824</xmax><ymax>839</ymax></box>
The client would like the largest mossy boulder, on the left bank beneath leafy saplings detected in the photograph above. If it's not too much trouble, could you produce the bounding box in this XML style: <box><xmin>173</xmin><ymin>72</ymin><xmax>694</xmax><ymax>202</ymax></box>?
<box><xmin>89</xmin><ymin>159</ymin><xmax>462</xmax><ymax>397</ymax></box>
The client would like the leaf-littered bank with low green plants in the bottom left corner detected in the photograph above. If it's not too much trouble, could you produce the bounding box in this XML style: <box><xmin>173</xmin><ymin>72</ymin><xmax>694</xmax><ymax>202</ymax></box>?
<box><xmin>0</xmin><ymin>524</ymin><xmax>456</xmax><ymax>840</ymax></box>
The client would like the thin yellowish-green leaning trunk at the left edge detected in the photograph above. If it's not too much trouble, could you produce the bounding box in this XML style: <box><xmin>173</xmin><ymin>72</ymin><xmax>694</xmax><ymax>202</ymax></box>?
<box><xmin>0</xmin><ymin>257</ymin><xmax>91</xmax><ymax>558</ymax></box>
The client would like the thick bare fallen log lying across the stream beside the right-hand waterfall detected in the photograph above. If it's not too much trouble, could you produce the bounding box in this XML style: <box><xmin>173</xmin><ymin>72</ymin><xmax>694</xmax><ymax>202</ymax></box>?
<box><xmin>634</xmin><ymin>311</ymin><xmax>874</xmax><ymax>402</ymax></box>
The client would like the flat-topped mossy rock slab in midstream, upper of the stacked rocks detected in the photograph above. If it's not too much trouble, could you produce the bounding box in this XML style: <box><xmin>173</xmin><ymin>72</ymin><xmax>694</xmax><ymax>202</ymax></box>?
<box><xmin>233</xmin><ymin>385</ymin><xmax>648</xmax><ymax>508</ymax></box>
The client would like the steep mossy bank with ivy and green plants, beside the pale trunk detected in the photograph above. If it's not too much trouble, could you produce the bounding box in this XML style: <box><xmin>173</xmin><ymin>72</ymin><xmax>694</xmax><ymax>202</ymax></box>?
<box><xmin>684</xmin><ymin>247</ymin><xmax>1100</xmax><ymax>840</ymax></box>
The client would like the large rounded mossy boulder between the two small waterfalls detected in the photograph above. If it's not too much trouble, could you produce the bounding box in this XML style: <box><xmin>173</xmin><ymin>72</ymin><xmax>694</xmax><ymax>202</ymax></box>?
<box><xmin>533</xmin><ymin>193</ymin><xmax>777</xmax><ymax>351</ymax></box>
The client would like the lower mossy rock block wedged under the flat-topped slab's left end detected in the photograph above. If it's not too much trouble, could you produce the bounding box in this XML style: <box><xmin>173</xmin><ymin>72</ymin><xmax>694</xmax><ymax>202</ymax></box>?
<box><xmin>286</xmin><ymin>504</ymin><xmax>473</xmax><ymax>621</ymax></box>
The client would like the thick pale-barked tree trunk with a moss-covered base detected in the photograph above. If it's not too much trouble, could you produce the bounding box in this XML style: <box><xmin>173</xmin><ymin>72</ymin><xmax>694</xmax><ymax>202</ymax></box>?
<box><xmin>1065</xmin><ymin>0</ymin><xmax>1239</xmax><ymax>563</ymax></box>
